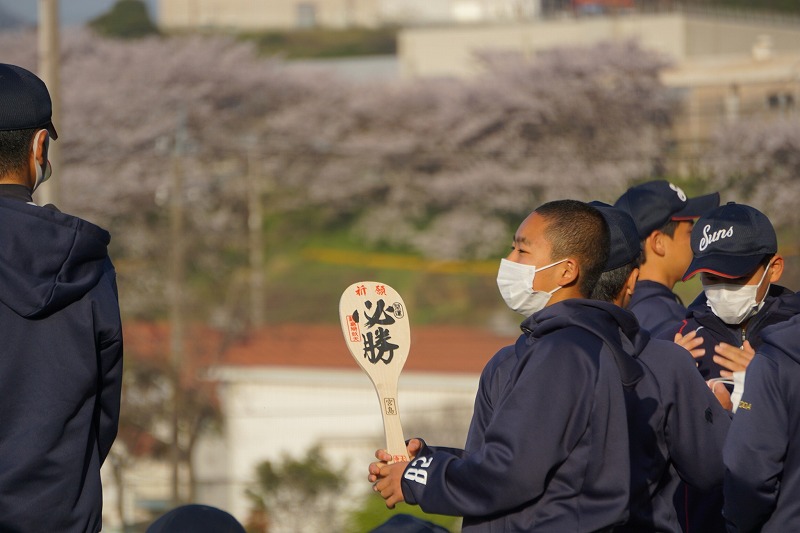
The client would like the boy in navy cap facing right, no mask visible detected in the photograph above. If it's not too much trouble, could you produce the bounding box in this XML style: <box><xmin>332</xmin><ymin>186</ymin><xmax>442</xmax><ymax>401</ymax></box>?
<box><xmin>614</xmin><ymin>180</ymin><xmax>719</xmax><ymax>335</ymax></box>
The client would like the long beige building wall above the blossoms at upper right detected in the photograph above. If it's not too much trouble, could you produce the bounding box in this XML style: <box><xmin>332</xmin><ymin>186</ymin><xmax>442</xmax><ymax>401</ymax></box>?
<box><xmin>398</xmin><ymin>12</ymin><xmax>800</xmax><ymax>78</ymax></box>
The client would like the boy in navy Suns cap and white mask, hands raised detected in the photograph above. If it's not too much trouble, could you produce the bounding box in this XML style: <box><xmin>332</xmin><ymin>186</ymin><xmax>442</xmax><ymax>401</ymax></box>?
<box><xmin>663</xmin><ymin>202</ymin><xmax>800</xmax><ymax>533</ymax></box>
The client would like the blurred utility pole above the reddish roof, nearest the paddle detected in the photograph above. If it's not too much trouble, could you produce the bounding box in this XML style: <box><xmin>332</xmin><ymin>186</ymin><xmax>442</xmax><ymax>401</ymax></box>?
<box><xmin>247</xmin><ymin>142</ymin><xmax>264</xmax><ymax>329</ymax></box>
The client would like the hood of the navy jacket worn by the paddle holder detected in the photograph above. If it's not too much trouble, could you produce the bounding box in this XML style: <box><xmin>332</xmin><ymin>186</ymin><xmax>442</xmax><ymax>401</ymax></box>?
<box><xmin>517</xmin><ymin>298</ymin><xmax>650</xmax><ymax>387</ymax></box>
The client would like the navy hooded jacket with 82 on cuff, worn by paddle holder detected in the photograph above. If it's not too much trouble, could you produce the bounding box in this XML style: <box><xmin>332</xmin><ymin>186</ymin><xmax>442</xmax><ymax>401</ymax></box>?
<box><xmin>403</xmin><ymin>299</ymin><xmax>642</xmax><ymax>533</ymax></box>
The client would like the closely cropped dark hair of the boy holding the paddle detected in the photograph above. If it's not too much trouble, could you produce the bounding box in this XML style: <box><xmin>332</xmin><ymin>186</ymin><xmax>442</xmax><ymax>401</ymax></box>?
<box><xmin>535</xmin><ymin>200</ymin><xmax>610</xmax><ymax>298</ymax></box>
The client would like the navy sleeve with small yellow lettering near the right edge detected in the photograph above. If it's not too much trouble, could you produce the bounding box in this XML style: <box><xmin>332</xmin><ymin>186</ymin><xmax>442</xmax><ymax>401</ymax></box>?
<box><xmin>723</xmin><ymin>352</ymin><xmax>789</xmax><ymax>531</ymax></box>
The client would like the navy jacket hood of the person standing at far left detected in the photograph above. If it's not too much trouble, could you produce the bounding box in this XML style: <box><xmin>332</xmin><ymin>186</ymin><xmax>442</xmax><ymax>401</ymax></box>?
<box><xmin>0</xmin><ymin>198</ymin><xmax>111</xmax><ymax>318</ymax></box>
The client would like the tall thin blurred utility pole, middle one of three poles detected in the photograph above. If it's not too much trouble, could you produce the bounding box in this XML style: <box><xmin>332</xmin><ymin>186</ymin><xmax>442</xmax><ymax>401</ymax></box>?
<box><xmin>168</xmin><ymin>109</ymin><xmax>187</xmax><ymax>506</ymax></box>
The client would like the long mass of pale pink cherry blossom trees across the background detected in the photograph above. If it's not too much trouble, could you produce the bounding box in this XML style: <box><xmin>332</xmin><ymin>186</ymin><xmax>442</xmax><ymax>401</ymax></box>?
<box><xmin>0</xmin><ymin>32</ymin><xmax>674</xmax><ymax>268</ymax></box>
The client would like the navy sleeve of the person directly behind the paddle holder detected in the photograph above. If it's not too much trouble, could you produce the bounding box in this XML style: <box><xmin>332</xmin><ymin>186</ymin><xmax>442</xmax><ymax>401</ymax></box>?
<box><xmin>655</xmin><ymin>343</ymin><xmax>731</xmax><ymax>490</ymax></box>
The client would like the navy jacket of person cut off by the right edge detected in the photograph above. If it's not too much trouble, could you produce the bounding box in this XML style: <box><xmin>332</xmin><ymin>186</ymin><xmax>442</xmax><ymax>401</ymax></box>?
<box><xmin>723</xmin><ymin>316</ymin><xmax>800</xmax><ymax>533</ymax></box>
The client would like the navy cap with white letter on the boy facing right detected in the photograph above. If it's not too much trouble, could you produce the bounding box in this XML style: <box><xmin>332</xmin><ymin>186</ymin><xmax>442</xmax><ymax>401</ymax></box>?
<box><xmin>614</xmin><ymin>180</ymin><xmax>719</xmax><ymax>239</ymax></box>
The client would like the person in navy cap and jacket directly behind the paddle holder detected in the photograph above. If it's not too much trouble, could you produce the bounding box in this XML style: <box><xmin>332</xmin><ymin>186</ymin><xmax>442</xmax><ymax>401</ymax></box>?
<box><xmin>592</xmin><ymin>204</ymin><xmax>730</xmax><ymax>533</ymax></box>
